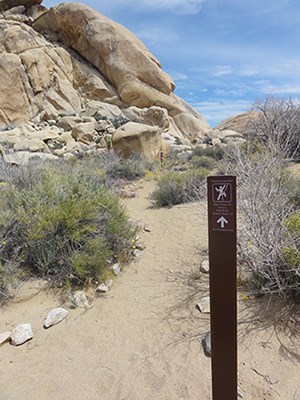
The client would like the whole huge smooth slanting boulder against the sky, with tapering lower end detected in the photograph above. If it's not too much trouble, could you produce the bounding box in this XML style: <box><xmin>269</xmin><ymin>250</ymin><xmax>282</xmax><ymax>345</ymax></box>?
<box><xmin>54</xmin><ymin>3</ymin><xmax>211</xmax><ymax>138</ymax></box>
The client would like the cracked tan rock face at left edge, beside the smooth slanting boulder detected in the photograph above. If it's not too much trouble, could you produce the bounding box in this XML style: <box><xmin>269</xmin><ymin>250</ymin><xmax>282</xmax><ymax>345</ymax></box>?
<box><xmin>0</xmin><ymin>21</ymin><xmax>81</xmax><ymax>130</ymax></box>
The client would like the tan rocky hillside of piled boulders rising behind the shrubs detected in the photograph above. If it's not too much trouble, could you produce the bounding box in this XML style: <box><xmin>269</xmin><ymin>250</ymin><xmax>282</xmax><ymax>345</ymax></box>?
<box><xmin>0</xmin><ymin>0</ymin><xmax>216</xmax><ymax>162</ymax></box>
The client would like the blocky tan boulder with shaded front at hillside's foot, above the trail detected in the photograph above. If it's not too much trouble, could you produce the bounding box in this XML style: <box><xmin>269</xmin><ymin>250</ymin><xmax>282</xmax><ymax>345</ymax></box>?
<box><xmin>113</xmin><ymin>122</ymin><xmax>162</xmax><ymax>160</ymax></box>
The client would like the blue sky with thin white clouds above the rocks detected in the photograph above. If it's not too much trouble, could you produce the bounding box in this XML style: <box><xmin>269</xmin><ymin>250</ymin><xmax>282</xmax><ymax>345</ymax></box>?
<box><xmin>43</xmin><ymin>0</ymin><xmax>300</xmax><ymax>127</ymax></box>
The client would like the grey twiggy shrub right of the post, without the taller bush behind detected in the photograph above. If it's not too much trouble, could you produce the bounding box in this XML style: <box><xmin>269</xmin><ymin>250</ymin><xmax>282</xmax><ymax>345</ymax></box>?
<box><xmin>223</xmin><ymin>144</ymin><xmax>300</xmax><ymax>299</ymax></box>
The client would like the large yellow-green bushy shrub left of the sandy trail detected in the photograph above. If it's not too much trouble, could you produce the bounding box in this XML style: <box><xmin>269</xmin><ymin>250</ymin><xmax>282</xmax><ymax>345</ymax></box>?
<box><xmin>0</xmin><ymin>160</ymin><xmax>136</xmax><ymax>291</ymax></box>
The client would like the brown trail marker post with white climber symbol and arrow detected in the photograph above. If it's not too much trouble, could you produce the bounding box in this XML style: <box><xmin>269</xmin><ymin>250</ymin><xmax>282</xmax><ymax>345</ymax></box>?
<box><xmin>207</xmin><ymin>176</ymin><xmax>237</xmax><ymax>400</ymax></box>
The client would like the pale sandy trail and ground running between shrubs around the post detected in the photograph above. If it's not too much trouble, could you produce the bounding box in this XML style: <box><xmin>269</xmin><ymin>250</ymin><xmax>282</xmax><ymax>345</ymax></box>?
<box><xmin>0</xmin><ymin>182</ymin><xmax>300</xmax><ymax>400</ymax></box>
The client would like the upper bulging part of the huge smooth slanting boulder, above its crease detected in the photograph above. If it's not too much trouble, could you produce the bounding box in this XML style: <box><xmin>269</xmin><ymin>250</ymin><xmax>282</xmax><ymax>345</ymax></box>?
<box><xmin>55</xmin><ymin>3</ymin><xmax>174</xmax><ymax>103</ymax></box>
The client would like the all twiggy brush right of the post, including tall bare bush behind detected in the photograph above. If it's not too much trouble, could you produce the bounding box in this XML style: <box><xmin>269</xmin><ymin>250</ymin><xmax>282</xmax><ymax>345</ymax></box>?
<box><xmin>222</xmin><ymin>98</ymin><xmax>300</xmax><ymax>302</ymax></box>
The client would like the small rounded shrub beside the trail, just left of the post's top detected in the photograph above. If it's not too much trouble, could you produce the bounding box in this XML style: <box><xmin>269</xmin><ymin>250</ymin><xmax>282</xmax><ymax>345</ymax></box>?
<box><xmin>151</xmin><ymin>168</ymin><xmax>209</xmax><ymax>207</ymax></box>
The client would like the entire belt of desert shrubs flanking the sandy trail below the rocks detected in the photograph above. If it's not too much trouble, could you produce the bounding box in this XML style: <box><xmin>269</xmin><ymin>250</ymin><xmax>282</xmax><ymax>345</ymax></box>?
<box><xmin>0</xmin><ymin>98</ymin><xmax>300</xmax><ymax>301</ymax></box>
